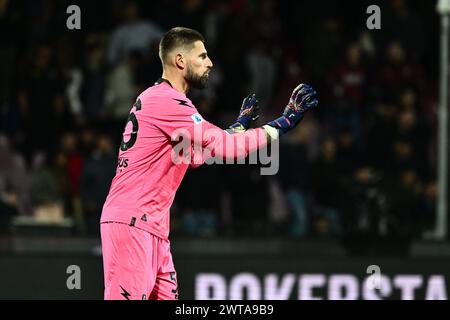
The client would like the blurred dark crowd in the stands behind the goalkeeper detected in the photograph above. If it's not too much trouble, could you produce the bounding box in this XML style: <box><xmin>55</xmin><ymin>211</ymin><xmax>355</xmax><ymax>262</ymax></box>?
<box><xmin>0</xmin><ymin>0</ymin><xmax>438</xmax><ymax>240</ymax></box>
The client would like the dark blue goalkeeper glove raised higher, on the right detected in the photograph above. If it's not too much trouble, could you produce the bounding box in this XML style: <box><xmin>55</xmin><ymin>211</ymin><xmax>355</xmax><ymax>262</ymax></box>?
<box><xmin>267</xmin><ymin>83</ymin><xmax>319</xmax><ymax>137</ymax></box>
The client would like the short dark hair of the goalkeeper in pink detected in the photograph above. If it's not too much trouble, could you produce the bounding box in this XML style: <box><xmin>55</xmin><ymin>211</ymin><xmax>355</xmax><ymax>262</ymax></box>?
<box><xmin>159</xmin><ymin>27</ymin><xmax>205</xmax><ymax>64</ymax></box>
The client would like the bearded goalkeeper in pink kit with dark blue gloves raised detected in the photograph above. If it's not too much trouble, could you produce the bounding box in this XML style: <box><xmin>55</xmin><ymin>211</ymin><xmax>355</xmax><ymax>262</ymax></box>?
<box><xmin>100</xmin><ymin>27</ymin><xmax>318</xmax><ymax>300</ymax></box>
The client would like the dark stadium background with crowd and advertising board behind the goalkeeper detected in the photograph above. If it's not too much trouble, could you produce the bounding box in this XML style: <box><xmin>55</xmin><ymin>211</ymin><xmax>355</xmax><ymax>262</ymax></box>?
<box><xmin>0</xmin><ymin>0</ymin><xmax>450</xmax><ymax>299</ymax></box>
